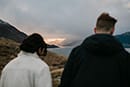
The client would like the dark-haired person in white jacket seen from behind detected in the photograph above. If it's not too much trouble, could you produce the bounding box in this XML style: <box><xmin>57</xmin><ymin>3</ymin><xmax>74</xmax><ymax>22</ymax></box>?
<box><xmin>0</xmin><ymin>33</ymin><xmax>52</xmax><ymax>87</ymax></box>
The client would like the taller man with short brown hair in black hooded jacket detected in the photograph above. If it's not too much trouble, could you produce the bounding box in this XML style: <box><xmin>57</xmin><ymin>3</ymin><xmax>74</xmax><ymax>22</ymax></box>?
<box><xmin>59</xmin><ymin>13</ymin><xmax>130</xmax><ymax>87</ymax></box>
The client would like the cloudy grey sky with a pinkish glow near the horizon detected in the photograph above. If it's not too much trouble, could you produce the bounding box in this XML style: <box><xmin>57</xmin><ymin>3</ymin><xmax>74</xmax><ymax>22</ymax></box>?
<box><xmin>0</xmin><ymin>0</ymin><xmax>130</xmax><ymax>43</ymax></box>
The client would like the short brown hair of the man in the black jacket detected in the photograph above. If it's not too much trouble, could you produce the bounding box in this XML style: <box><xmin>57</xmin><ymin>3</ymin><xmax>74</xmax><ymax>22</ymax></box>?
<box><xmin>96</xmin><ymin>13</ymin><xmax>117</xmax><ymax>31</ymax></box>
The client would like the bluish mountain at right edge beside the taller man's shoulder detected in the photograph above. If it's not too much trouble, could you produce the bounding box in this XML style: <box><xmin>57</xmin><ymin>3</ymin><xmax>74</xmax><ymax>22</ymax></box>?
<box><xmin>115</xmin><ymin>32</ymin><xmax>130</xmax><ymax>48</ymax></box>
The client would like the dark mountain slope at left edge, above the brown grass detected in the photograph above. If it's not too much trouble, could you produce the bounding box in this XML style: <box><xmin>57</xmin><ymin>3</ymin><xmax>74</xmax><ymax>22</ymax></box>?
<box><xmin>0</xmin><ymin>20</ymin><xmax>27</xmax><ymax>43</ymax></box>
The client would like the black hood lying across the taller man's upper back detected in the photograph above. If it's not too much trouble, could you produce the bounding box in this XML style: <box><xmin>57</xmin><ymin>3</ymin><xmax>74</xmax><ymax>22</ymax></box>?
<box><xmin>82</xmin><ymin>34</ymin><xmax>123</xmax><ymax>55</ymax></box>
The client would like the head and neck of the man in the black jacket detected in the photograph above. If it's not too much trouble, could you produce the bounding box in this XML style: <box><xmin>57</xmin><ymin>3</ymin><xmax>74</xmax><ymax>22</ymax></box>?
<box><xmin>95</xmin><ymin>13</ymin><xmax>117</xmax><ymax>34</ymax></box>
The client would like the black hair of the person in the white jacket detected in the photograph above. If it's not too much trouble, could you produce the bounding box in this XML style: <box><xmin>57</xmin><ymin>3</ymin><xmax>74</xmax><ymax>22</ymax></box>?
<box><xmin>20</xmin><ymin>33</ymin><xmax>47</xmax><ymax>56</ymax></box>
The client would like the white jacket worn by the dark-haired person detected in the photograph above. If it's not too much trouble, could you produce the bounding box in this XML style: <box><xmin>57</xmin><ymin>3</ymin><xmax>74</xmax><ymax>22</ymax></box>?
<box><xmin>0</xmin><ymin>51</ymin><xmax>52</xmax><ymax>87</ymax></box>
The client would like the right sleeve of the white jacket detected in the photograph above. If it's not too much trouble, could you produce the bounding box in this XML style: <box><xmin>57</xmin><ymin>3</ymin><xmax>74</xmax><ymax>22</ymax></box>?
<box><xmin>35</xmin><ymin>67</ymin><xmax>52</xmax><ymax>87</ymax></box>
